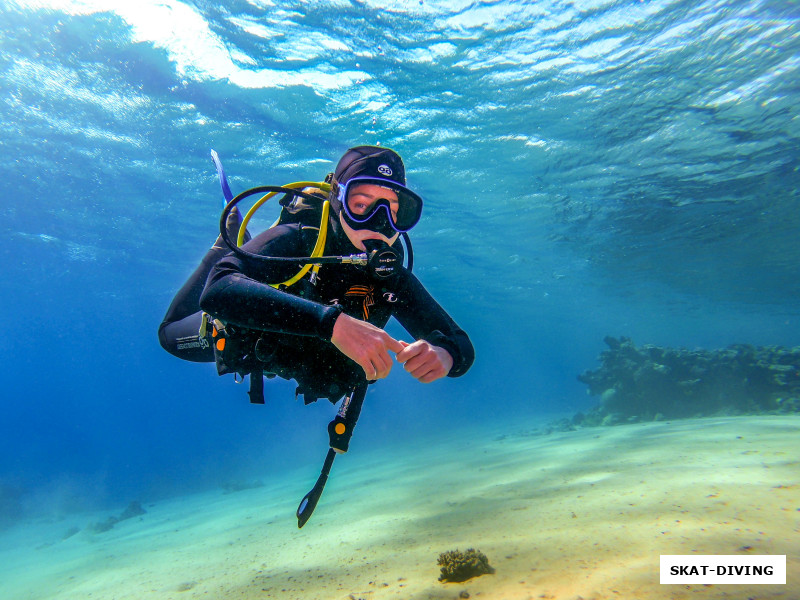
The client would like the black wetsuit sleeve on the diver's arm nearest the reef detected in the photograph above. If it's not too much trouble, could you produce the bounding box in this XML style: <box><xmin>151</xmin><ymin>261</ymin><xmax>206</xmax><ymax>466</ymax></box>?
<box><xmin>393</xmin><ymin>271</ymin><xmax>475</xmax><ymax>377</ymax></box>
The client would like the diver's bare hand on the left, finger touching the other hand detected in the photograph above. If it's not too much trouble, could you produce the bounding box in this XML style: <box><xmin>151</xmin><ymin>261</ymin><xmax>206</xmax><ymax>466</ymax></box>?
<box><xmin>331</xmin><ymin>313</ymin><xmax>403</xmax><ymax>381</ymax></box>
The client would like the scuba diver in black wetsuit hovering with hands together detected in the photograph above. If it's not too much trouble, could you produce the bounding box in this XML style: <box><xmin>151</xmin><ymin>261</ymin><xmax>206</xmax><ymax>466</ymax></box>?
<box><xmin>159</xmin><ymin>146</ymin><xmax>475</xmax><ymax>527</ymax></box>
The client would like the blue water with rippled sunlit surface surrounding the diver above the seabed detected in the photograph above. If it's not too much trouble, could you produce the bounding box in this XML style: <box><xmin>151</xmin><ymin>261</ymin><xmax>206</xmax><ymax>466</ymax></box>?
<box><xmin>0</xmin><ymin>0</ymin><xmax>800</xmax><ymax>518</ymax></box>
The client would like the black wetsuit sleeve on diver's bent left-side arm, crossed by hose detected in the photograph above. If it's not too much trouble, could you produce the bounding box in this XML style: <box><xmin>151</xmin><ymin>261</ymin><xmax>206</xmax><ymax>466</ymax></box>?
<box><xmin>200</xmin><ymin>226</ymin><xmax>341</xmax><ymax>340</ymax></box>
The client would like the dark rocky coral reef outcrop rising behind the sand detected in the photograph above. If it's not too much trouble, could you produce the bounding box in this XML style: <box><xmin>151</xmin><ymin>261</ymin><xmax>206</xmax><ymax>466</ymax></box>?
<box><xmin>578</xmin><ymin>337</ymin><xmax>800</xmax><ymax>426</ymax></box>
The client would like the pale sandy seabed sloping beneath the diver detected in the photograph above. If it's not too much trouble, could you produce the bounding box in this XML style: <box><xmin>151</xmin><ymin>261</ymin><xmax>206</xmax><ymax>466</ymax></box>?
<box><xmin>0</xmin><ymin>416</ymin><xmax>800</xmax><ymax>600</ymax></box>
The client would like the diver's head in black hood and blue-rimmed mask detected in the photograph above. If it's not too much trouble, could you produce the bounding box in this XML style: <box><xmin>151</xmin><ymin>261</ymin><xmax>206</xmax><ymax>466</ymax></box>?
<box><xmin>330</xmin><ymin>146</ymin><xmax>422</xmax><ymax>250</ymax></box>
